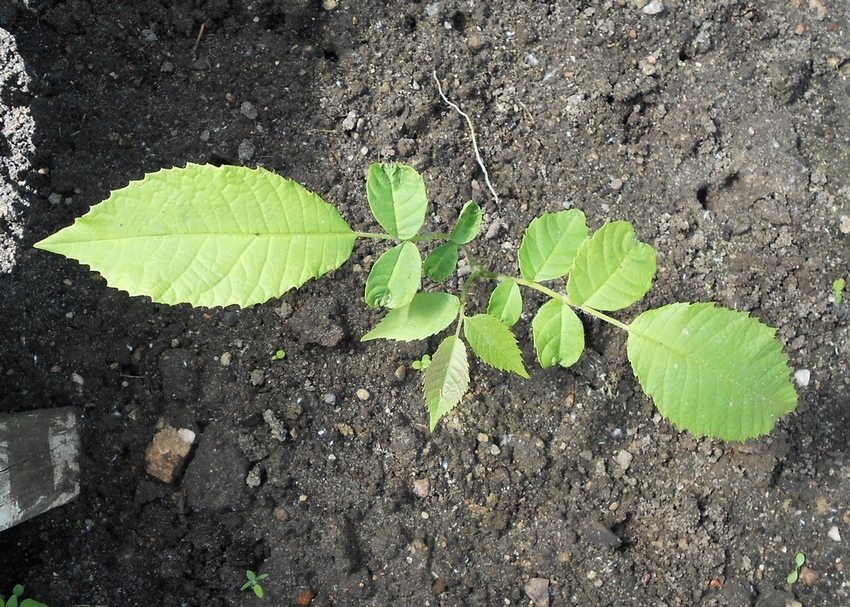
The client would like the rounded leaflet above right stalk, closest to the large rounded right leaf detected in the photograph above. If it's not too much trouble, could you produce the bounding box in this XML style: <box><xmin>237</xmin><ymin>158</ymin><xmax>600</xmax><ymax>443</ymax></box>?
<box><xmin>567</xmin><ymin>221</ymin><xmax>655</xmax><ymax>311</ymax></box>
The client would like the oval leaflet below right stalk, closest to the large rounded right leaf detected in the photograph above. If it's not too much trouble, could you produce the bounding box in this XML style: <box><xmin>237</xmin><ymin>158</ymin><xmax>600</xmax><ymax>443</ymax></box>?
<box><xmin>531</xmin><ymin>299</ymin><xmax>584</xmax><ymax>369</ymax></box>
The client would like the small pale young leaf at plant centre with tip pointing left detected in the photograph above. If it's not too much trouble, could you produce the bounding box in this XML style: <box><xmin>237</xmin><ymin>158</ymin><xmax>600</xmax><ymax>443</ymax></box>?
<box><xmin>360</xmin><ymin>293</ymin><xmax>460</xmax><ymax>341</ymax></box>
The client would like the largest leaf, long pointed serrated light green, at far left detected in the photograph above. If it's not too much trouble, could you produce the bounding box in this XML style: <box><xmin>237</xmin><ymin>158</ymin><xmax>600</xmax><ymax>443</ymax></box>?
<box><xmin>35</xmin><ymin>164</ymin><xmax>356</xmax><ymax>307</ymax></box>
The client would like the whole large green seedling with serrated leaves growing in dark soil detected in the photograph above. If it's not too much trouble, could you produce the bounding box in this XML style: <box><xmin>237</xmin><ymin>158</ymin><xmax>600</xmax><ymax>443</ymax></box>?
<box><xmin>35</xmin><ymin>163</ymin><xmax>797</xmax><ymax>441</ymax></box>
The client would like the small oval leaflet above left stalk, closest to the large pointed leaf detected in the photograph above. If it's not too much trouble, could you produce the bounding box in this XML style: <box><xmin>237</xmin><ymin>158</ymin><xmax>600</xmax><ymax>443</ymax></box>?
<box><xmin>366</xmin><ymin>162</ymin><xmax>428</xmax><ymax>240</ymax></box>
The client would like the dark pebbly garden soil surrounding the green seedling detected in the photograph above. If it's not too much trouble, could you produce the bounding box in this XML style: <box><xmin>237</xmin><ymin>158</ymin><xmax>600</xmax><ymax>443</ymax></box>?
<box><xmin>0</xmin><ymin>0</ymin><xmax>850</xmax><ymax>607</ymax></box>
